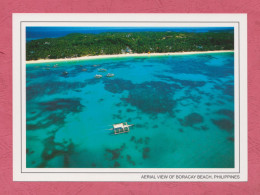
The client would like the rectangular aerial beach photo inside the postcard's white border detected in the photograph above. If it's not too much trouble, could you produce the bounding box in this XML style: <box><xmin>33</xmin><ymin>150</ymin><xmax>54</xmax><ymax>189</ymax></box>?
<box><xmin>26</xmin><ymin>26</ymin><xmax>235</xmax><ymax>169</ymax></box>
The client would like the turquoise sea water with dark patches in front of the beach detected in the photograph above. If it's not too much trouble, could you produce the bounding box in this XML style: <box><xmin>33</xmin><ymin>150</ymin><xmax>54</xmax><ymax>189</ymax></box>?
<box><xmin>26</xmin><ymin>53</ymin><xmax>234</xmax><ymax>168</ymax></box>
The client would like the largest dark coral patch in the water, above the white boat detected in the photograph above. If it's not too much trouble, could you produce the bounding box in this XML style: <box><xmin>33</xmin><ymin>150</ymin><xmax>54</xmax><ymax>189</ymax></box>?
<box><xmin>103</xmin><ymin>79</ymin><xmax>175</xmax><ymax>114</ymax></box>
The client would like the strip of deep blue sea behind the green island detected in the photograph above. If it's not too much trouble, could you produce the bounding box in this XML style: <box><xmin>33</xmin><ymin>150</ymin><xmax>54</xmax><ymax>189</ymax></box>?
<box><xmin>26</xmin><ymin>27</ymin><xmax>234</xmax><ymax>42</ymax></box>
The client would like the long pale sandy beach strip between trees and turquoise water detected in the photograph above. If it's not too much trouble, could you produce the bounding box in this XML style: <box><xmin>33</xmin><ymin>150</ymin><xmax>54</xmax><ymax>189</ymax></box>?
<box><xmin>26</xmin><ymin>50</ymin><xmax>234</xmax><ymax>64</ymax></box>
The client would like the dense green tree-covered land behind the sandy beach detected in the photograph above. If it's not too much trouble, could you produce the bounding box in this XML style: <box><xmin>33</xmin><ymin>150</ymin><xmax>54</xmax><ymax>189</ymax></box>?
<box><xmin>26</xmin><ymin>31</ymin><xmax>234</xmax><ymax>60</ymax></box>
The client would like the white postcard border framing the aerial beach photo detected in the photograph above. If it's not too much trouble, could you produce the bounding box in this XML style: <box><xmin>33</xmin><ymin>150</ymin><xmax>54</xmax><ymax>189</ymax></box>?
<box><xmin>13</xmin><ymin>14</ymin><xmax>247</xmax><ymax>181</ymax></box>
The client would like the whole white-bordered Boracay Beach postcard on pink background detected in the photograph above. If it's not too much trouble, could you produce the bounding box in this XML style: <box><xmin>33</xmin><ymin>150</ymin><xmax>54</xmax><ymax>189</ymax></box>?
<box><xmin>13</xmin><ymin>14</ymin><xmax>247</xmax><ymax>182</ymax></box>
